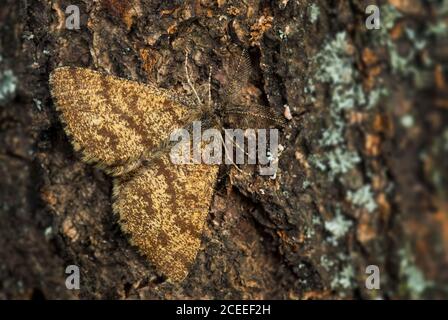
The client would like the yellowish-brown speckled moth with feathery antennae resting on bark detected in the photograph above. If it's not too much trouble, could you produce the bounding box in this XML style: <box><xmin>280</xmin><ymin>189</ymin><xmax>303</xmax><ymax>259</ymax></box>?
<box><xmin>49</xmin><ymin>51</ymin><xmax>283</xmax><ymax>282</ymax></box>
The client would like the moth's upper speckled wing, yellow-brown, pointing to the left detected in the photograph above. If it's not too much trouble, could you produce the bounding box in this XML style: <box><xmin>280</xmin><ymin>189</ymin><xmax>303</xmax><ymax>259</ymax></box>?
<box><xmin>50</xmin><ymin>67</ymin><xmax>189</xmax><ymax>176</ymax></box>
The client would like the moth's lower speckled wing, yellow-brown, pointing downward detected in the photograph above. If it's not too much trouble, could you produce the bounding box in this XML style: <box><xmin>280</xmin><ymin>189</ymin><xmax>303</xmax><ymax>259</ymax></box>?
<box><xmin>114</xmin><ymin>155</ymin><xmax>219</xmax><ymax>281</ymax></box>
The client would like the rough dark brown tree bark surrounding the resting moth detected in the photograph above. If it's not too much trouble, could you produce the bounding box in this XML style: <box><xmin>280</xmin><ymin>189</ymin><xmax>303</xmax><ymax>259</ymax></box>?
<box><xmin>0</xmin><ymin>0</ymin><xmax>448</xmax><ymax>299</ymax></box>
